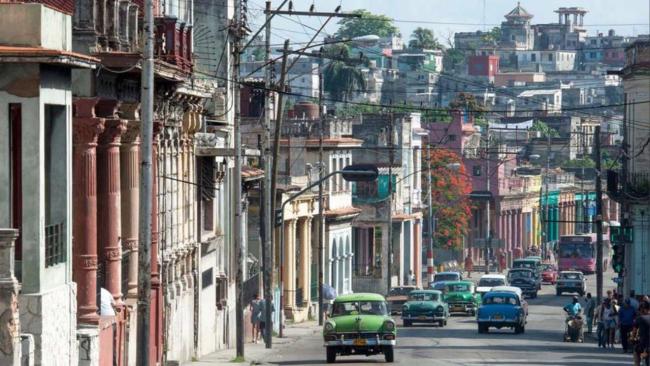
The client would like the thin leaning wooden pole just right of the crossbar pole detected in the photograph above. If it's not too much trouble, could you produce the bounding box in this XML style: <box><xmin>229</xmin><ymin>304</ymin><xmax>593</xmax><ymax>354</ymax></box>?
<box><xmin>271</xmin><ymin>39</ymin><xmax>289</xmax><ymax>338</ymax></box>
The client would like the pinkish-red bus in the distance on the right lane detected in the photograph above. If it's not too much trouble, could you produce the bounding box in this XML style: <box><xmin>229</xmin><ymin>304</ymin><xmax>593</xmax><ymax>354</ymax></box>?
<box><xmin>557</xmin><ymin>234</ymin><xmax>607</xmax><ymax>274</ymax></box>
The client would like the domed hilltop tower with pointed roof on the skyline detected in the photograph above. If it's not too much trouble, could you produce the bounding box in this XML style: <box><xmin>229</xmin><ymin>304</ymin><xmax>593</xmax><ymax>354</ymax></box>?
<box><xmin>501</xmin><ymin>2</ymin><xmax>535</xmax><ymax>50</ymax></box>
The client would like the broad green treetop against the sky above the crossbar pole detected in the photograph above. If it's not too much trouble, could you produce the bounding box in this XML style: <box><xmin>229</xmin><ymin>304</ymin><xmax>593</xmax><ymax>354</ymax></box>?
<box><xmin>334</xmin><ymin>9</ymin><xmax>399</xmax><ymax>38</ymax></box>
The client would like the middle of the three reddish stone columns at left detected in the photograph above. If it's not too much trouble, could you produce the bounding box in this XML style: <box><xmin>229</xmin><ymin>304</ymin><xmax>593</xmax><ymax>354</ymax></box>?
<box><xmin>97</xmin><ymin>101</ymin><xmax>126</xmax><ymax>304</ymax></box>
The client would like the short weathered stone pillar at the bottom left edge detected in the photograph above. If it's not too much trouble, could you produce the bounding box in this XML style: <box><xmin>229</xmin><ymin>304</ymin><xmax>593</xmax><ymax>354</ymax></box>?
<box><xmin>0</xmin><ymin>229</ymin><xmax>22</xmax><ymax>366</ymax></box>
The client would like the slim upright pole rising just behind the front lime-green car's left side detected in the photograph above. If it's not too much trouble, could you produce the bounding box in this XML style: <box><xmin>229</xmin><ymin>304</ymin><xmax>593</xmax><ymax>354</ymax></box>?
<box><xmin>318</xmin><ymin>70</ymin><xmax>325</xmax><ymax>325</ymax></box>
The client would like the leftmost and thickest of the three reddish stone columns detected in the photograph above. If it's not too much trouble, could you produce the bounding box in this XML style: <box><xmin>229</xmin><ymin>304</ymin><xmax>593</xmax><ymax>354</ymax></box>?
<box><xmin>72</xmin><ymin>99</ymin><xmax>104</xmax><ymax>324</ymax></box>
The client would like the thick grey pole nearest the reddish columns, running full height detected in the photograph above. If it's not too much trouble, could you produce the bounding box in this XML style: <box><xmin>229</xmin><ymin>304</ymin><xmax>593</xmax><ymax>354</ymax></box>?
<box><xmin>137</xmin><ymin>0</ymin><xmax>155</xmax><ymax>360</ymax></box>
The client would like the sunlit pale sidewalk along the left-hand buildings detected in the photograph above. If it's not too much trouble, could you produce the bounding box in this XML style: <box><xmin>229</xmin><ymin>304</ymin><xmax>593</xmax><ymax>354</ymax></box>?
<box><xmin>183</xmin><ymin>321</ymin><xmax>320</xmax><ymax>366</ymax></box>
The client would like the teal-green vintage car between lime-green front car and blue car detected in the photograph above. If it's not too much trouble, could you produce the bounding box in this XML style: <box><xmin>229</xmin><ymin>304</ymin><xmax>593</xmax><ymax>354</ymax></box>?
<box><xmin>402</xmin><ymin>290</ymin><xmax>449</xmax><ymax>327</ymax></box>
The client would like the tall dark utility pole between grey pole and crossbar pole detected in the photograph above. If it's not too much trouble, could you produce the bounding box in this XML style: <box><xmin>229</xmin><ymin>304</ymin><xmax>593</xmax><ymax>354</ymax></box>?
<box><xmin>232</xmin><ymin>0</ymin><xmax>246</xmax><ymax>358</ymax></box>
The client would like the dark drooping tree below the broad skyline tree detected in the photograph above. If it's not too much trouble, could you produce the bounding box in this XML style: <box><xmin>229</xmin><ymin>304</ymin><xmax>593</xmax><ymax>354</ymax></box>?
<box><xmin>323</xmin><ymin>44</ymin><xmax>366</xmax><ymax>101</ymax></box>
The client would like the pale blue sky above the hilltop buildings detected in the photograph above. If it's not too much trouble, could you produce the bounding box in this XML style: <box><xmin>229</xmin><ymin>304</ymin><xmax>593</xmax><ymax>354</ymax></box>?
<box><xmin>249</xmin><ymin>0</ymin><xmax>650</xmax><ymax>44</ymax></box>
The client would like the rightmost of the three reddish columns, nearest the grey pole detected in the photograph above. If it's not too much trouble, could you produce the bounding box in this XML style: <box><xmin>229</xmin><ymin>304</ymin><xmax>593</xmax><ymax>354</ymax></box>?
<box><xmin>120</xmin><ymin>115</ymin><xmax>140</xmax><ymax>299</ymax></box>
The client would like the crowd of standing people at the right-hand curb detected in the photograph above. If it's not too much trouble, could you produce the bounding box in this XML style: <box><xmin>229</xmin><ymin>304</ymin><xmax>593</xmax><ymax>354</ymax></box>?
<box><xmin>584</xmin><ymin>290</ymin><xmax>650</xmax><ymax>365</ymax></box>
